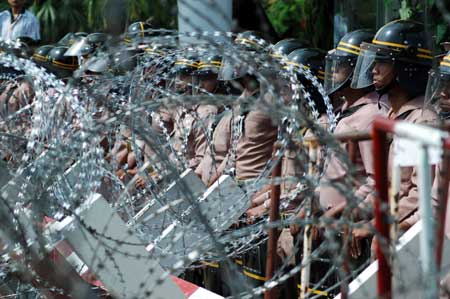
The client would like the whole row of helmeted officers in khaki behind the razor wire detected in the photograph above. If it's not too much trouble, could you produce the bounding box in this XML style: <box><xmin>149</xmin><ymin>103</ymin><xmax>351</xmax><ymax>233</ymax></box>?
<box><xmin>0</xmin><ymin>20</ymin><xmax>450</xmax><ymax>296</ymax></box>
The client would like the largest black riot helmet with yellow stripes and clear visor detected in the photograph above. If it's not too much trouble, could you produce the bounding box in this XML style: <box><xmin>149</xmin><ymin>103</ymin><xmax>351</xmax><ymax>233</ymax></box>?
<box><xmin>351</xmin><ymin>20</ymin><xmax>433</xmax><ymax>98</ymax></box>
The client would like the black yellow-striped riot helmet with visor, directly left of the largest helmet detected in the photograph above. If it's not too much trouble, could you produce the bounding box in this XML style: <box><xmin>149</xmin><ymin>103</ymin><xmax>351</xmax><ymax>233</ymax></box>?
<box><xmin>324</xmin><ymin>29</ymin><xmax>375</xmax><ymax>95</ymax></box>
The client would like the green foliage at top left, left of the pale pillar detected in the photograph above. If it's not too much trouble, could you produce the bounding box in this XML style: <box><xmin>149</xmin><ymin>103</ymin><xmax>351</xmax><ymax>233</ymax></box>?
<box><xmin>0</xmin><ymin>0</ymin><xmax>177</xmax><ymax>43</ymax></box>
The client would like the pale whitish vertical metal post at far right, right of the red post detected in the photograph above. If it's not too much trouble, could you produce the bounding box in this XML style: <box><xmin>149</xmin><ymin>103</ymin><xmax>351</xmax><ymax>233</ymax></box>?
<box><xmin>417</xmin><ymin>145</ymin><xmax>438</xmax><ymax>299</ymax></box>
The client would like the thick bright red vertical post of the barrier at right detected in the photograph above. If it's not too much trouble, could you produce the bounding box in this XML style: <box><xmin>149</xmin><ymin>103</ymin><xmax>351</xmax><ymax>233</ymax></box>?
<box><xmin>372</xmin><ymin>120</ymin><xmax>393</xmax><ymax>299</ymax></box>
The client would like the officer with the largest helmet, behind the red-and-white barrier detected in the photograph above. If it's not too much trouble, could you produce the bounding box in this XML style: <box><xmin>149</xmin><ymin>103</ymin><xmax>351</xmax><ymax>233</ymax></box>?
<box><xmin>340</xmin><ymin>20</ymin><xmax>437</xmax><ymax>256</ymax></box>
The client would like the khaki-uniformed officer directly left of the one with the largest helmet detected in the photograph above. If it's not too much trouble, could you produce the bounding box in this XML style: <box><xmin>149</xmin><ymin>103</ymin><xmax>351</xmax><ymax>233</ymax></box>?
<box><xmin>280</xmin><ymin>30</ymin><xmax>389</xmax><ymax>255</ymax></box>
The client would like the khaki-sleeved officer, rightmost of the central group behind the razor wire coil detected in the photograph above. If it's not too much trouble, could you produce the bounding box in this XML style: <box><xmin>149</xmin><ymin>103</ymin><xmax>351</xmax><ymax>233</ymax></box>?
<box><xmin>197</xmin><ymin>36</ymin><xmax>278</xmax><ymax>285</ymax></box>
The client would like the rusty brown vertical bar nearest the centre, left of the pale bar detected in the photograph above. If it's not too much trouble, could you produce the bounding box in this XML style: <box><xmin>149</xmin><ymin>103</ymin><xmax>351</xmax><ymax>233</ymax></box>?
<box><xmin>264</xmin><ymin>148</ymin><xmax>281</xmax><ymax>299</ymax></box>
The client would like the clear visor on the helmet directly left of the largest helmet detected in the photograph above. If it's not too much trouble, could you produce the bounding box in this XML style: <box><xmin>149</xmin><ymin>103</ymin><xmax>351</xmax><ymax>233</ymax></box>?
<box><xmin>324</xmin><ymin>55</ymin><xmax>354</xmax><ymax>95</ymax></box>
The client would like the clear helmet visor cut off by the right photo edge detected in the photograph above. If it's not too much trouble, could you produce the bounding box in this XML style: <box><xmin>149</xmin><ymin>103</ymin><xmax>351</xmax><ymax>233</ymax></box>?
<box><xmin>425</xmin><ymin>70</ymin><xmax>450</xmax><ymax>113</ymax></box>
